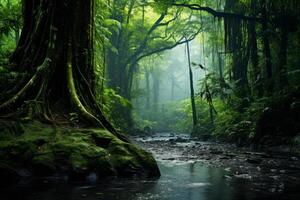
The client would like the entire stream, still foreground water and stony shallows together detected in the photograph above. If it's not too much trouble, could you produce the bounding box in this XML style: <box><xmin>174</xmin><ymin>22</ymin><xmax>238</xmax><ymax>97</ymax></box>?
<box><xmin>0</xmin><ymin>133</ymin><xmax>300</xmax><ymax>200</ymax></box>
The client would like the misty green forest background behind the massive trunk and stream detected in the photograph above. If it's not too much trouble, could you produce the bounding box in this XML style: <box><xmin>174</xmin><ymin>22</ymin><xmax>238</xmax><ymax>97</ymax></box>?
<box><xmin>0</xmin><ymin>0</ymin><xmax>300</xmax><ymax>147</ymax></box>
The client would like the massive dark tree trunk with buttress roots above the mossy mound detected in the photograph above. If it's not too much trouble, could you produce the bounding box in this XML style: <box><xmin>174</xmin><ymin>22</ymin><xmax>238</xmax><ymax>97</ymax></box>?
<box><xmin>0</xmin><ymin>0</ymin><xmax>126</xmax><ymax>140</ymax></box>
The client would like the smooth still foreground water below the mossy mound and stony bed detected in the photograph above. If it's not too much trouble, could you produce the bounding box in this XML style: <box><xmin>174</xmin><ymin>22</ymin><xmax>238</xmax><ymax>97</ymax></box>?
<box><xmin>0</xmin><ymin>133</ymin><xmax>299</xmax><ymax>200</ymax></box>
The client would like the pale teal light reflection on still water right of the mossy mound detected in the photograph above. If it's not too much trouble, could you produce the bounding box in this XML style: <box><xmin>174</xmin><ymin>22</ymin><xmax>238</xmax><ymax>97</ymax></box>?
<box><xmin>156</xmin><ymin>162</ymin><xmax>232</xmax><ymax>200</ymax></box>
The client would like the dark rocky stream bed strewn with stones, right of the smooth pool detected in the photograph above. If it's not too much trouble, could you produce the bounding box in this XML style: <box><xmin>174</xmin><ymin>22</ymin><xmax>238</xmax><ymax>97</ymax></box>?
<box><xmin>135</xmin><ymin>133</ymin><xmax>300</xmax><ymax>199</ymax></box>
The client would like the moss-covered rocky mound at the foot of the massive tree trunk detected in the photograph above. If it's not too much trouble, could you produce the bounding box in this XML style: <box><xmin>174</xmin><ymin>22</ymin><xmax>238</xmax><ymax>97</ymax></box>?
<box><xmin>0</xmin><ymin>122</ymin><xmax>159</xmax><ymax>180</ymax></box>
